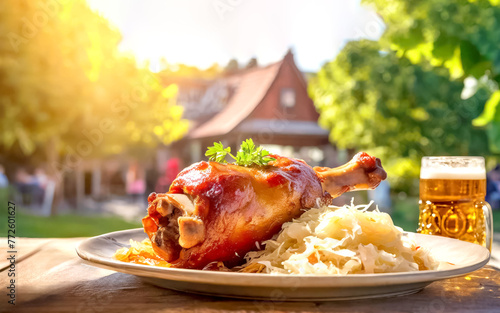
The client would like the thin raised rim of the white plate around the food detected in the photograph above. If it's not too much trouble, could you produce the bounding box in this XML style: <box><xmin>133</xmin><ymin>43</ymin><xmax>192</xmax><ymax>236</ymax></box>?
<box><xmin>75</xmin><ymin>228</ymin><xmax>491</xmax><ymax>288</ymax></box>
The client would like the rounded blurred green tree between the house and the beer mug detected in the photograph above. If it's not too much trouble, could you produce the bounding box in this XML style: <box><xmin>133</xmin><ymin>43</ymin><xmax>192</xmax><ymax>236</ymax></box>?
<box><xmin>309</xmin><ymin>40</ymin><xmax>489</xmax><ymax>186</ymax></box>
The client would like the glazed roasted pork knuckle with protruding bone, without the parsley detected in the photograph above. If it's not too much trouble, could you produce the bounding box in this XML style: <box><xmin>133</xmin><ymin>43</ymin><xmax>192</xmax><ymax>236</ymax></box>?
<box><xmin>142</xmin><ymin>152</ymin><xmax>387</xmax><ymax>269</ymax></box>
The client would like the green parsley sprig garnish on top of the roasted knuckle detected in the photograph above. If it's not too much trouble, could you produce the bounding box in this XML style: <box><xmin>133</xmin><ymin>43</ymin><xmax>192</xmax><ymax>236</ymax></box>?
<box><xmin>205</xmin><ymin>139</ymin><xmax>276</xmax><ymax>166</ymax></box>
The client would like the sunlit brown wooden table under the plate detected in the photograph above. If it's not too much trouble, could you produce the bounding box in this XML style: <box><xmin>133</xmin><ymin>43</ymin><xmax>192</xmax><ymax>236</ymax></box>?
<box><xmin>0</xmin><ymin>238</ymin><xmax>500</xmax><ymax>313</ymax></box>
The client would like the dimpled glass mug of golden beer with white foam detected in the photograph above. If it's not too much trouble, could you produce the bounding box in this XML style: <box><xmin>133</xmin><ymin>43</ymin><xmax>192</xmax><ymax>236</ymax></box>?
<box><xmin>417</xmin><ymin>157</ymin><xmax>493</xmax><ymax>251</ymax></box>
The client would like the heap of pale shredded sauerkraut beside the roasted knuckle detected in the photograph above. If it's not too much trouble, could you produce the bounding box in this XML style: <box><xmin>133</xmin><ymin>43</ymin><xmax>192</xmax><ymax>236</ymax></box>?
<box><xmin>242</xmin><ymin>203</ymin><xmax>439</xmax><ymax>275</ymax></box>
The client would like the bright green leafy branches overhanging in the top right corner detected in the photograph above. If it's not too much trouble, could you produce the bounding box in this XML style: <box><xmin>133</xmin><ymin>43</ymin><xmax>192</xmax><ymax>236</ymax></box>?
<box><xmin>364</xmin><ymin>0</ymin><xmax>500</xmax><ymax>153</ymax></box>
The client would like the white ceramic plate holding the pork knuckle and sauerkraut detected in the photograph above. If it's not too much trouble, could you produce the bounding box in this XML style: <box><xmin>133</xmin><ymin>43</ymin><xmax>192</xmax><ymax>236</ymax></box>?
<box><xmin>76</xmin><ymin>228</ymin><xmax>490</xmax><ymax>301</ymax></box>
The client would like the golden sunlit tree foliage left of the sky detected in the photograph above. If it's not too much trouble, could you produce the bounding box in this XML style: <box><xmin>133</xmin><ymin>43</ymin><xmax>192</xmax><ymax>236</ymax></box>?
<box><xmin>0</xmin><ymin>0</ymin><xmax>187</xmax><ymax>165</ymax></box>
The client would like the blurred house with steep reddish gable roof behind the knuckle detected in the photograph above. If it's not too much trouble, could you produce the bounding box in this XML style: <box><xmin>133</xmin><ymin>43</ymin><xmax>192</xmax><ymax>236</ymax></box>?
<box><xmin>160</xmin><ymin>51</ymin><xmax>339</xmax><ymax>166</ymax></box>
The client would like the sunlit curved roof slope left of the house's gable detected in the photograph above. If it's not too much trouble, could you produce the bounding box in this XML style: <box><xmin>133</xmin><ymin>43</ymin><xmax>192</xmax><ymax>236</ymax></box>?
<box><xmin>189</xmin><ymin>61</ymin><xmax>283</xmax><ymax>138</ymax></box>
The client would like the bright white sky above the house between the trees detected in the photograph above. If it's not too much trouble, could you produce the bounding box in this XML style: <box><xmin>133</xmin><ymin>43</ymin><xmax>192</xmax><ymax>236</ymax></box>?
<box><xmin>87</xmin><ymin>0</ymin><xmax>384</xmax><ymax>72</ymax></box>
